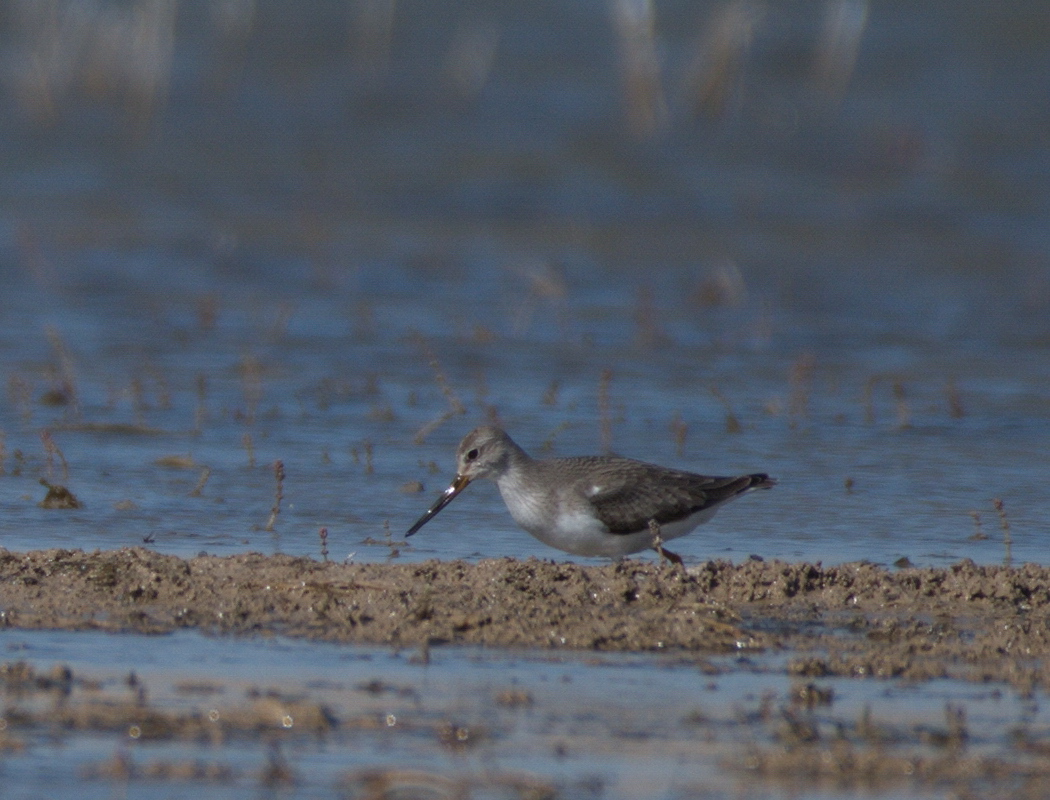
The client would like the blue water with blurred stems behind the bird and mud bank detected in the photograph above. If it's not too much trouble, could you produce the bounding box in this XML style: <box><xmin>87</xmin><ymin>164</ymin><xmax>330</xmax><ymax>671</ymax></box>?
<box><xmin>0</xmin><ymin>0</ymin><xmax>1050</xmax><ymax>564</ymax></box>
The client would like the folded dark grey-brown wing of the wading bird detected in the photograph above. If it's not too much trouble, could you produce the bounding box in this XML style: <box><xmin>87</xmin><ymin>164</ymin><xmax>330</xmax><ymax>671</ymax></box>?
<box><xmin>558</xmin><ymin>459</ymin><xmax>773</xmax><ymax>534</ymax></box>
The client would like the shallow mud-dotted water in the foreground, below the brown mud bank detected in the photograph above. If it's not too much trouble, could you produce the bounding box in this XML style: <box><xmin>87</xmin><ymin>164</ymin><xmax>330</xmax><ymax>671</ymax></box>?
<box><xmin>0</xmin><ymin>631</ymin><xmax>1050</xmax><ymax>798</ymax></box>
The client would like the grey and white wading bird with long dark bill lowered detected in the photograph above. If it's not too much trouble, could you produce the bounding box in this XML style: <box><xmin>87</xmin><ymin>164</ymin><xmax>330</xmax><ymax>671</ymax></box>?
<box><xmin>405</xmin><ymin>425</ymin><xmax>776</xmax><ymax>564</ymax></box>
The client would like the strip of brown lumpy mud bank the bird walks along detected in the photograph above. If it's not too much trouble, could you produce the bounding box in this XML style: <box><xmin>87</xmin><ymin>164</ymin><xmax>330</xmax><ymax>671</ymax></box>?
<box><xmin>0</xmin><ymin>548</ymin><xmax>1050</xmax><ymax>691</ymax></box>
